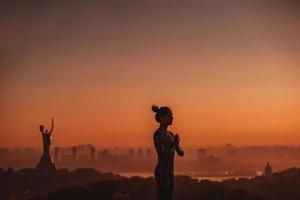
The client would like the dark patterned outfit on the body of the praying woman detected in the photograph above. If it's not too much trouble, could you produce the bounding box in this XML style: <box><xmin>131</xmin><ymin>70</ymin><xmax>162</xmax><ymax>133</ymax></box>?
<box><xmin>153</xmin><ymin>130</ymin><xmax>175</xmax><ymax>200</ymax></box>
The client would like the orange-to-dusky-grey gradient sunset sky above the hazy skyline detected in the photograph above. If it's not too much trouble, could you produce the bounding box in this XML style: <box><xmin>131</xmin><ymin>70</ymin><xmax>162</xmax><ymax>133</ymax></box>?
<box><xmin>0</xmin><ymin>0</ymin><xmax>300</xmax><ymax>147</ymax></box>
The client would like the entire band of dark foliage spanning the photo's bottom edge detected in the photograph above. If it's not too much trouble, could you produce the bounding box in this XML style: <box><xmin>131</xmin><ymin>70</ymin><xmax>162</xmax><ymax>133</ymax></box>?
<box><xmin>4</xmin><ymin>168</ymin><xmax>300</xmax><ymax>200</ymax></box>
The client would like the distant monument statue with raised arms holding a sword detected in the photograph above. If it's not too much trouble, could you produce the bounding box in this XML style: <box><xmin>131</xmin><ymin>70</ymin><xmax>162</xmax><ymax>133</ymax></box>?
<box><xmin>36</xmin><ymin>118</ymin><xmax>56</xmax><ymax>173</ymax></box>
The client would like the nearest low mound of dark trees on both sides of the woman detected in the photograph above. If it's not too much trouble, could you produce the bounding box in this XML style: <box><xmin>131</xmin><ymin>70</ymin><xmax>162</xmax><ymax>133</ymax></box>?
<box><xmin>34</xmin><ymin>176</ymin><xmax>257</xmax><ymax>200</ymax></box>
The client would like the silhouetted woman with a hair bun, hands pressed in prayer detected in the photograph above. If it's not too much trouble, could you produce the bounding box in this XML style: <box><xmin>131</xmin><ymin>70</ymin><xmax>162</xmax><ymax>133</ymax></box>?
<box><xmin>152</xmin><ymin>106</ymin><xmax>184</xmax><ymax>200</ymax></box>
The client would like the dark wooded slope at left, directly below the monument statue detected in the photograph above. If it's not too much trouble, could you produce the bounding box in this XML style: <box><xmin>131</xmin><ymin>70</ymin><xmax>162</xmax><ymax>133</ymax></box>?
<box><xmin>0</xmin><ymin>168</ymin><xmax>121</xmax><ymax>200</ymax></box>
